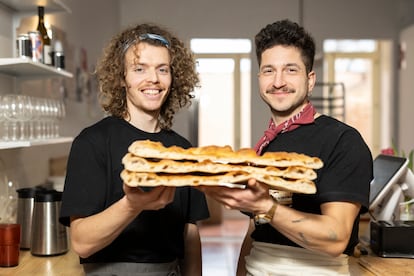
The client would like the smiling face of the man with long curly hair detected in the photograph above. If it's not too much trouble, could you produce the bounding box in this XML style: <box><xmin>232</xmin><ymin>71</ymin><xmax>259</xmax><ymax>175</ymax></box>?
<box><xmin>124</xmin><ymin>42</ymin><xmax>172</xmax><ymax>121</ymax></box>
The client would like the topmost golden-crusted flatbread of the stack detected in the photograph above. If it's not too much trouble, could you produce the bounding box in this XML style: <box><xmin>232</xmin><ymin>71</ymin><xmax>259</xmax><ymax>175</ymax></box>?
<box><xmin>128</xmin><ymin>140</ymin><xmax>323</xmax><ymax>169</ymax></box>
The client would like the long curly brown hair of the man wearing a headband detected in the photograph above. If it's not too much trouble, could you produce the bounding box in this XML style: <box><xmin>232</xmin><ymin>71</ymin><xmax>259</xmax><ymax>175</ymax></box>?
<box><xmin>96</xmin><ymin>24</ymin><xmax>199</xmax><ymax>129</ymax></box>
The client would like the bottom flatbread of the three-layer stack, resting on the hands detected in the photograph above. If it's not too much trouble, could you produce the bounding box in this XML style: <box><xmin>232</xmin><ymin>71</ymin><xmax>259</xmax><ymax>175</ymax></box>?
<box><xmin>121</xmin><ymin>170</ymin><xmax>316</xmax><ymax>194</ymax></box>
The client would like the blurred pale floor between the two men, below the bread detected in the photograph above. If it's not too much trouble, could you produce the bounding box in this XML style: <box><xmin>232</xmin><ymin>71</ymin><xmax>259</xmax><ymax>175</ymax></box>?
<box><xmin>200</xmin><ymin>218</ymin><xmax>248</xmax><ymax>276</ymax></box>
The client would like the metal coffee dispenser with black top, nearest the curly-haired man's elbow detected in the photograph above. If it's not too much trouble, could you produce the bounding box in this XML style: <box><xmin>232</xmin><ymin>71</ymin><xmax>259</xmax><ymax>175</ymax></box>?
<box><xmin>30</xmin><ymin>190</ymin><xmax>68</xmax><ymax>256</ymax></box>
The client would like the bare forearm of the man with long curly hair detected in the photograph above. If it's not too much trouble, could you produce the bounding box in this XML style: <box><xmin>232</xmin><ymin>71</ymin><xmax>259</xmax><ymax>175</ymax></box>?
<box><xmin>70</xmin><ymin>197</ymin><xmax>139</xmax><ymax>258</ymax></box>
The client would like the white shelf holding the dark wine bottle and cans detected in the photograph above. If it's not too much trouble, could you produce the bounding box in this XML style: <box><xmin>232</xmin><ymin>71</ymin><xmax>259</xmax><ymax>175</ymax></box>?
<box><xmin>0</xmin><ymin>58</ymin><xmax>73</xmax><ymax>78</ymax></box>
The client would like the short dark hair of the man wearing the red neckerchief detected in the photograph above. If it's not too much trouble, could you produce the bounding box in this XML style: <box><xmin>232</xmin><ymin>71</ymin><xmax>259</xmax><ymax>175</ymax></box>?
<box><xmin>255</xmin><ymin>19</ymin><xmax>315</xmax><ymax>73</ymax></box>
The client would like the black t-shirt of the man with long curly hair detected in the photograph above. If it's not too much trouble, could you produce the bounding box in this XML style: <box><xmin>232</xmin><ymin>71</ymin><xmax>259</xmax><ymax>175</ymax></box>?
<box><xmin>60</xmin><ymin>117</ymin><xmax>209</xmax><ymax>263</ymax></box>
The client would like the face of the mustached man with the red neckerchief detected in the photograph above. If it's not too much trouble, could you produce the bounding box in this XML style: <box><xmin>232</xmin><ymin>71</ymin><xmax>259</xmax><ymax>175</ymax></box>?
<box><xmin>259</xmin><ymin>45</ymin><xmax>315</xmax><ymax>124</ymax></box>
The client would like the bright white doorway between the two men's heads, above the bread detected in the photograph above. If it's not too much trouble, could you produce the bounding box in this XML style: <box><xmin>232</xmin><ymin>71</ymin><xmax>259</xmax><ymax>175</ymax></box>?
<box><xmin>191</xmin><ymin>39</ymin><xmax>251</xmax><ymax>149</ymax></box>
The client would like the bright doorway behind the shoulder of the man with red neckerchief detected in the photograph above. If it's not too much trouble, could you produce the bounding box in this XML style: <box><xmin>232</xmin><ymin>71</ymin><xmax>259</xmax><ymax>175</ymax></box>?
<box><xmin>324</xmin><ymin>40</ymin><xmax>391</xmax><ymax>156</ymax></box>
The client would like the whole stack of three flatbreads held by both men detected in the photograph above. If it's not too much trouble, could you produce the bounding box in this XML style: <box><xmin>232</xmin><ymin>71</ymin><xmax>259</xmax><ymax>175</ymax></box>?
<box><xmin>121</xmin><ymin>140</ymin><xmax>323</xmax><ymax>194</ymax></box>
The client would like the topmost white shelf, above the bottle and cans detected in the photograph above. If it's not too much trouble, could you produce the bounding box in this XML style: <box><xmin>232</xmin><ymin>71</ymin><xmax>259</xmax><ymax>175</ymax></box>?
<box><xmin>0</xmin><ymin>0</ymin><xmax>72</xmax><ymax>14</ymax></box>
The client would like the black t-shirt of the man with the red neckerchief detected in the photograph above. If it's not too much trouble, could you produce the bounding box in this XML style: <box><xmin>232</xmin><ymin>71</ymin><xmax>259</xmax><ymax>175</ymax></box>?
<box><xmin>252</xmin><ymin>115</ymin><xmax>373</xmax><ymax>255</ymax></box>
